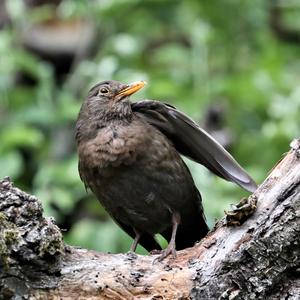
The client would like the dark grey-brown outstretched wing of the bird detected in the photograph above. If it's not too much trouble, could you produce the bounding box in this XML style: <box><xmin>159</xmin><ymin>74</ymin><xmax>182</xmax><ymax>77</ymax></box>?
<box><xmin>132</xmin><ymin>100</ymin><xmax>257</xmax><ymax>192</ymax></box>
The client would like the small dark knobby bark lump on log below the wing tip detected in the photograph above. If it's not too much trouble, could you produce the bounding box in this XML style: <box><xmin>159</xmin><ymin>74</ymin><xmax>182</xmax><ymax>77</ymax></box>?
<box><xmin>225</xmin><ymin>195</ymin><xmax>257</xmax><ymax>226</ymax></box>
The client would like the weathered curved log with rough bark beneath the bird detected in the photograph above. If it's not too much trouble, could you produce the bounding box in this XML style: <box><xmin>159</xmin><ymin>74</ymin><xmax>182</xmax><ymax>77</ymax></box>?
<box><xmin>0</xmin><ymin>140</ymin><xmax>300</xmax><ymax>299</ymax></box>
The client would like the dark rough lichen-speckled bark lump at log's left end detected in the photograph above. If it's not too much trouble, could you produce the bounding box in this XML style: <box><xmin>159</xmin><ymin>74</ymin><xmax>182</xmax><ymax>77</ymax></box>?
<box><xmin>0</xmin><ymin>178</ymin><xmax>64</xmax><ymax>299</ymax></box>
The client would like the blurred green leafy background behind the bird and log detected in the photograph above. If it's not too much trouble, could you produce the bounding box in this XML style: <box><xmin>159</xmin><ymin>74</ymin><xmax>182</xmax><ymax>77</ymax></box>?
<box><xmin>0</xmin><ymin>0</ymin><xmax>300</xmax><ymax>253</ymax></box>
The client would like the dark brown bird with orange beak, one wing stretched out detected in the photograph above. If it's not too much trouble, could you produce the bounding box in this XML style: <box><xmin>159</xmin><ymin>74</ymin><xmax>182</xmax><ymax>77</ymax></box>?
<box><xmin>76</xmin><ymin>81</ymin><xmax>256</xmax><ymax>260</ymax></box>
